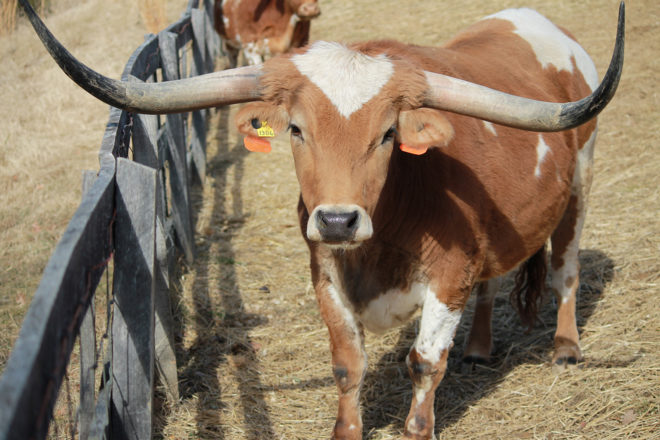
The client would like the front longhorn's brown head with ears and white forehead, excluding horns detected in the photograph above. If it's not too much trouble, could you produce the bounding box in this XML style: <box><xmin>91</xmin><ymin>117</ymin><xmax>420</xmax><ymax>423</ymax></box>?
<box><xmin>237</xmin><ymin>43</ymin><xmax>453</xmax><ymax>248</ymax></box>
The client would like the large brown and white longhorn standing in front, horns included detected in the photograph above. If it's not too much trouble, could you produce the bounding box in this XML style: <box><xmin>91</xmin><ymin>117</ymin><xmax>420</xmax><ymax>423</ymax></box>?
<box><xmin>22</xmin><ymin>0</ymin><xmax>624</xmax><ymax>439</ymax></box>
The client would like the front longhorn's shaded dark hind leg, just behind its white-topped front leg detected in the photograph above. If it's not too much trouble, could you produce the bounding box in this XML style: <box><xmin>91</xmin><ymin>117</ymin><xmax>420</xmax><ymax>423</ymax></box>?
<box><xmin>463</xmin><ymin>277</ymin><xmax>501</xmax><ymax>371</ymax></box>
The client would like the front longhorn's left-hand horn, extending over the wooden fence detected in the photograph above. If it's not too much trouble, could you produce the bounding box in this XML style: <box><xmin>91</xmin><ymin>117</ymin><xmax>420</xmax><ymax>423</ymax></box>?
<box><xmin>20</xmin><ymin>0</ymin><xmax>261</xmax><ymax>113</ymax></box>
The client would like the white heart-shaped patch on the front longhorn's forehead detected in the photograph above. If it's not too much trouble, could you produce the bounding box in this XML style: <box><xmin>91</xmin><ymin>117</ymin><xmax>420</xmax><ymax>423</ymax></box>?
<box><xmin>291</xmin><ymin>41</ymin><xmax>394</xmax><ymax>118</ymax></box>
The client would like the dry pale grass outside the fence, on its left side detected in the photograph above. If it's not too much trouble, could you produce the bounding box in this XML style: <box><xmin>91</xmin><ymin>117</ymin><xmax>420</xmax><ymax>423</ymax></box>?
<box><xmin>0</xmin><ymin>0</ymin><xmax>187</xmax><ymax>384</ymax></box>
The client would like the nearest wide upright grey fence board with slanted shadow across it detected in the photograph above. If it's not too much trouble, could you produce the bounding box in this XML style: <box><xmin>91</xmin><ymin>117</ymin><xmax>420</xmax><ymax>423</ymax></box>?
<box><xmin>111</xmin><ymin>158</ymin><xmax>157</xmax><ymax>440</ymax></box>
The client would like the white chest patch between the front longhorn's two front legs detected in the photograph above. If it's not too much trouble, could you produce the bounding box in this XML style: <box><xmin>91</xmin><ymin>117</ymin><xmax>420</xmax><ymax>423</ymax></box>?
<box><xmin>358</xmin><ymin>283</ymin><xmax>429</xmax><ymax>333</ymax></box>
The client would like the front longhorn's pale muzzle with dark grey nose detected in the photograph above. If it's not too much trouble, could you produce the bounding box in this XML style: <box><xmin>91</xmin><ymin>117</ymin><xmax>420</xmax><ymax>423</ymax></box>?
<box><xmin>307</xmin><ymin>205</ymin><xmax>373</xmax><ymax>248</ymax></box>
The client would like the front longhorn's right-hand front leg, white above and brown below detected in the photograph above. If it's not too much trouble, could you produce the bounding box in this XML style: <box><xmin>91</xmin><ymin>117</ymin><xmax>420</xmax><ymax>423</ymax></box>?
<box><xmin>404</xmin><ymin>289</ymin><xmax>462</xmax><ymax>439</ymax></box>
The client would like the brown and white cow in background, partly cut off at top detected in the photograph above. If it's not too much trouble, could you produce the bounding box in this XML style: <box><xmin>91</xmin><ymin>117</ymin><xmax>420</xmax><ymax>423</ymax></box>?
<box><xmin>214</xmin><ymin>0</ymin><xmax>321</xmax><ymax>66</ymax></box>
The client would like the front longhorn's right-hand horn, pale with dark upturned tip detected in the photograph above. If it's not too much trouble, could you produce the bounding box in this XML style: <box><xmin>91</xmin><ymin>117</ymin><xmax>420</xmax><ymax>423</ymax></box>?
<box><xmin>424</xmin><ymin>2</ymin><xmax>625</xmax><ymax>131</ymax></box>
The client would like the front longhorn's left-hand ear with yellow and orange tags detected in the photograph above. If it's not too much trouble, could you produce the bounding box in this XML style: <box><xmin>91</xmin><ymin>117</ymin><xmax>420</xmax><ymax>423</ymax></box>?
<box><xmin>235</xmin><ymin>102</ymin><xmax>289</xmax><ymax>153</ymax></box>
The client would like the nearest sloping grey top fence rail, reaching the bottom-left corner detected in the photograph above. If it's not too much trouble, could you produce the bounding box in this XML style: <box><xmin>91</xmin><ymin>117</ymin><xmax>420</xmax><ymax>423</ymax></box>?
<box><xmin>0</xmin><ymin>156</ymin><xmax>114</xmax><ymax>440</ymax></box>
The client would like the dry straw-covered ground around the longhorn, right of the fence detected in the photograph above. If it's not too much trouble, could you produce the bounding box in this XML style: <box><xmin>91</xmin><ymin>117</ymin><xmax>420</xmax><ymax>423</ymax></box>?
<box><xmin>161</xmin><ymin>0</ymin><xmax>660</xmax><ymax>439</ymax></box>
